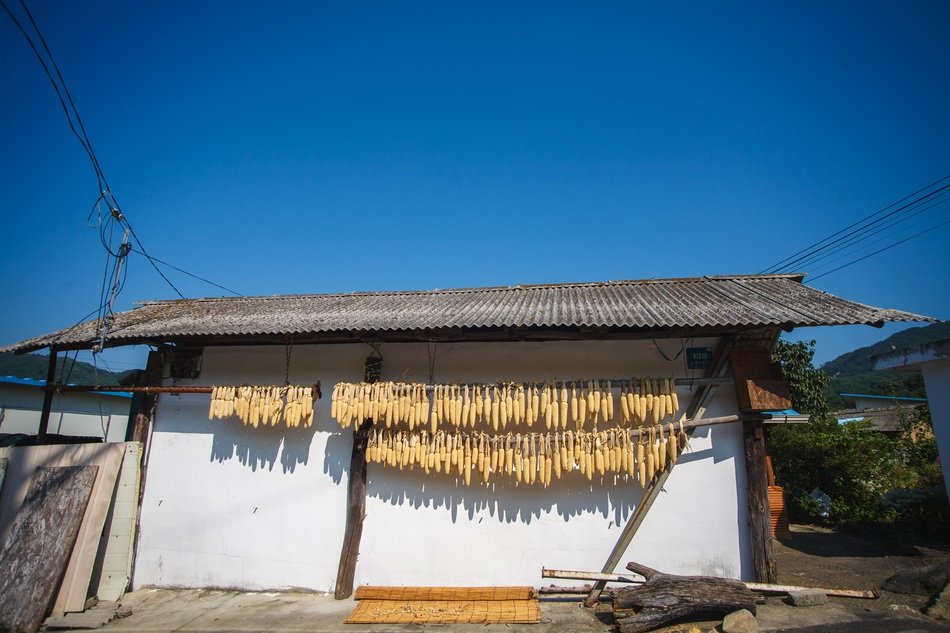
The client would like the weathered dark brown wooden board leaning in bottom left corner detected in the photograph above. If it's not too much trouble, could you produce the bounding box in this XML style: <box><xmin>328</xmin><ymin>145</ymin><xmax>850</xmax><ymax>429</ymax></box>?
<box><xmin>0</xmin><ymin>466</ymin><xmax>98</xmax><ymax>633</ymax></box>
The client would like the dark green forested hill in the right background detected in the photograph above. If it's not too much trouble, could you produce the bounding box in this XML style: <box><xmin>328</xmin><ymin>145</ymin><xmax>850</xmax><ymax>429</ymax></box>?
<box><xmin>821</xmin><ymin>322</ymin><xmax>950</xmax><ymax>409</ymax></box>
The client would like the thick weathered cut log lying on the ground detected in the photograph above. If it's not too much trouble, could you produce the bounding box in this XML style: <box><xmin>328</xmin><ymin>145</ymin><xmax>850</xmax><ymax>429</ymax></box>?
<box><xmin>614</xmin><ymin>563</ymin><xmax>755</xmax><ymax>633</ymax></box>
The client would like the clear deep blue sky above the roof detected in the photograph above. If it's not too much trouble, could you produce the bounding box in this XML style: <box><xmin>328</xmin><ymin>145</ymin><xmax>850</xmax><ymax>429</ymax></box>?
<box><xmin>0</xmin><ymin>0</ymin><xmax>950</xmax><ymax>369</ymax></box>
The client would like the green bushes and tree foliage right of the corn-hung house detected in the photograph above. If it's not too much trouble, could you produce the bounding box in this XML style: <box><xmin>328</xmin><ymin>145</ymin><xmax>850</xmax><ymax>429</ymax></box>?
<box><xmin>769</xmin><ymin>341</ymin><xmax>950</xmax><ymax>530</ymax></box>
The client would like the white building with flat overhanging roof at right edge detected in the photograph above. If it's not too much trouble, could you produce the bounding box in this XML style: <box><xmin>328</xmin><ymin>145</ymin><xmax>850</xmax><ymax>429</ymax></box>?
<box><xmin>871</xmin><ymin>339</ymin><xmax>950</xmax><ymax>496</ymax></box>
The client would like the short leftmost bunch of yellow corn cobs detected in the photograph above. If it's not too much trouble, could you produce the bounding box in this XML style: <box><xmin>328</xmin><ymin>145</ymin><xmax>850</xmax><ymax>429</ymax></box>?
<box><xmin>208</xmin><ymin>385</ymin><xmax>313</xmax><ymax>428</ymax></box>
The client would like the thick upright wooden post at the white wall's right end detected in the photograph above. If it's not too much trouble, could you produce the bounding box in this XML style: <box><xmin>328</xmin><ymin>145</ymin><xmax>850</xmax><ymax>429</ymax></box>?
<box><xmin>743</xmin><ymin>420</ymin><xmax>776</xmax><ymax>583</ymax></box>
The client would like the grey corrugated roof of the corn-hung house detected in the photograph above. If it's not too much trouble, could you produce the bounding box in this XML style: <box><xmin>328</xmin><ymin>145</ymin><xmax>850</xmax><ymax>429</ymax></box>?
<box><xmin>0</xmin><ymin>275</ymin><xmax>933</xmax><ymax>351</ymax></box>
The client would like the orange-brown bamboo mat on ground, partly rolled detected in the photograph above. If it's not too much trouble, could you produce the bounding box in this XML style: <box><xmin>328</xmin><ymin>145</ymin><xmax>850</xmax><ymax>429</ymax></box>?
<box><xmin>345</xmin><ymin>586</ymin><xmax>541</xmax><ymax>624</ymax></box>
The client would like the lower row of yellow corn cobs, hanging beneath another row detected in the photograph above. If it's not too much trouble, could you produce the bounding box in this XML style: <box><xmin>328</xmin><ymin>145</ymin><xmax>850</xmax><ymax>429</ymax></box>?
<box><xmin>366</xmin><ymin>422</ymin><xmax>686</xmax><ymax>487</ymax></box>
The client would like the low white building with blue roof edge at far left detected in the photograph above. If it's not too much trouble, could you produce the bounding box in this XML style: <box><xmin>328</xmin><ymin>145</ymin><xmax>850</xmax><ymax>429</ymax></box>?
<box><xmin>0</xmin><ymin>376</ymin><xmax>132</xmax><ymax>442</ymax></box>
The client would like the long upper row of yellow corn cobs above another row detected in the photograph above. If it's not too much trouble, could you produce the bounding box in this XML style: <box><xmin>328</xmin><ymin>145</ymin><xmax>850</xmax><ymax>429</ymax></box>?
<box><xmin>330</xmin><ymin>378</ymin><xmax>679</xmax><ymax>434</ymax></box>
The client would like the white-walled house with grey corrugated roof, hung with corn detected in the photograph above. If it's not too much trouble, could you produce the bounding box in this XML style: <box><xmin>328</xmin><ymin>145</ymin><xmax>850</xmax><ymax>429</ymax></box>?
<box><xmin>5</xmin><ymin>275</ymin><xmax>929</xmax><ymax>591</ymax></box>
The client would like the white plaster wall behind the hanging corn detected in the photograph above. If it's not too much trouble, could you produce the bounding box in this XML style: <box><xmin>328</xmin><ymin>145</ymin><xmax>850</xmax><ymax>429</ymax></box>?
<box><xmin>134</xmin><ymin>340</ymin><xmax>751</xmax><ymax>591</ymax></box>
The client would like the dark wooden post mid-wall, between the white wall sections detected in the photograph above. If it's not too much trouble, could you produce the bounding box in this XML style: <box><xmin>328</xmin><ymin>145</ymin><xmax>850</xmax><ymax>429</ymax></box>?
<box><xmin>333</xmin><ymin>356</ymin><xmax>383</xmax><ymax>600</ymax></box>
